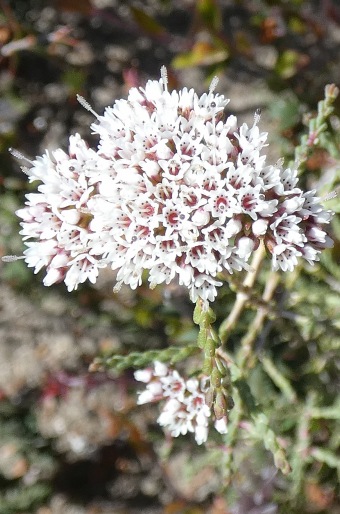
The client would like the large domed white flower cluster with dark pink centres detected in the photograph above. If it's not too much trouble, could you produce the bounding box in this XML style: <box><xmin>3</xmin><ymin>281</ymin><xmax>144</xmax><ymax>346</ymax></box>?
<box><xmin>17</xmin><ymin>68</ymin><xmax>332</xmax><ymax>301</ymax></box>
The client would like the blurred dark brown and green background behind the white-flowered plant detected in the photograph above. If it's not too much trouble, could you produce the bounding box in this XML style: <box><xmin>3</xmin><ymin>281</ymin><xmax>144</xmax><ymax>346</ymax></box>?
<box><xmin>0</xmin><ymin>0</ymin><xmax>340</xmax><ymax>514</ymax></box>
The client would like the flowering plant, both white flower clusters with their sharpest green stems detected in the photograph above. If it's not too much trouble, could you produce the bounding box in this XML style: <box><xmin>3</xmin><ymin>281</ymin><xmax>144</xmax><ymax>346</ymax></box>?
<box><xmin>4</xmin><ymin>68</ymin><xmax>336</xmax><ymax>484</ymax></box>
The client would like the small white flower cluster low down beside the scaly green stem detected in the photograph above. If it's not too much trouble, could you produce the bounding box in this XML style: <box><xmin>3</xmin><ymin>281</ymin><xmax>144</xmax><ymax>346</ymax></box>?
<box><xmin>135</xmin><ymin>361</ymin><xmax>227</xmax><ymax>444</ymax></box>
